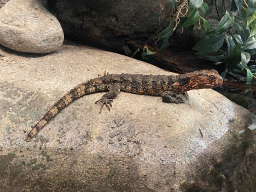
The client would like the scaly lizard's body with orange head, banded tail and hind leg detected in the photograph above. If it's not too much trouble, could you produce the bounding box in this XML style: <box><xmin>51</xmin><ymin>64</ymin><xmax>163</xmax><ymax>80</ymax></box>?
<box><xmin>26</xmin><ymin>70</ymin><xmax>223</xmax><ymax>142</ymax></box>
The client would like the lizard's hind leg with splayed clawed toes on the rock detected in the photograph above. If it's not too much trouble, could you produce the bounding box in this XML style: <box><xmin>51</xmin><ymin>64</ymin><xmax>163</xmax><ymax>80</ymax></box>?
<box><xmin>95</xmin><ymin>83</ymin><xmax>121</xmax><ymax>113</ymax></box>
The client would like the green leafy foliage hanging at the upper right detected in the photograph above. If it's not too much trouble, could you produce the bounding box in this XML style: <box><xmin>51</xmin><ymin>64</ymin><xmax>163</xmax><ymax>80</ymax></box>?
<box><xmin>125</xmin><ymin>0</ymin><xmax>256</xmax><ymax>83</ymax></box>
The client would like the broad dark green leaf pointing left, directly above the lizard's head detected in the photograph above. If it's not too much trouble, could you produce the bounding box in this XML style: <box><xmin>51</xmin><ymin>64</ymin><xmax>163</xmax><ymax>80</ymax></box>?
<box><xmin>193</xmin><ymin>35</ymin><xmax>224</xmax><ymax>52</ymax></box>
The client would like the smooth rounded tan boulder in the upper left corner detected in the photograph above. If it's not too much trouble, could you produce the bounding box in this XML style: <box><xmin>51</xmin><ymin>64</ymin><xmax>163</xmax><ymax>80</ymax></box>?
<box><xmin>0</xmin><ymin>0</ymin><xmax>64</xmax><ymax>53</ymax></box>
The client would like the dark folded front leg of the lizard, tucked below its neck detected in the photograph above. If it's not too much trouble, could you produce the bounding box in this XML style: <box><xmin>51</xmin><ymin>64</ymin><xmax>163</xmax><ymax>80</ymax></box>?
<box><xmin>161</xmin><ymin>91</ymin><xmax>188</xmax><ymax>103</ymax></box>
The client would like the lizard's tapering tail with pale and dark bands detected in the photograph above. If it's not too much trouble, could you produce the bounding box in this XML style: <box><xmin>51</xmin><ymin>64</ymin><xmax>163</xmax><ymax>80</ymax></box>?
<box><xmin>26</xmin><ymin>78</ymin><xmax>107</xmax><ymax>142</ymax></box>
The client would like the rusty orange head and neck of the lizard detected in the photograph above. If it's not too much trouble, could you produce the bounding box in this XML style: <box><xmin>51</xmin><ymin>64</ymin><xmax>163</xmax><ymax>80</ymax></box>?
<box><xmin>173</xmin><ymin>70</ymin><xmax>223</xmax><ymax>93</ymax></box>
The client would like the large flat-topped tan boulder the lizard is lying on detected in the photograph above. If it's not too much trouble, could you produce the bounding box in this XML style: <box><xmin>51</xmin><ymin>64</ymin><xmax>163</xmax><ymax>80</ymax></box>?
<box><xmin>0</xmin><ymin>43</ymin><xmax>256</xmax><ymax>192</ymax></box>
